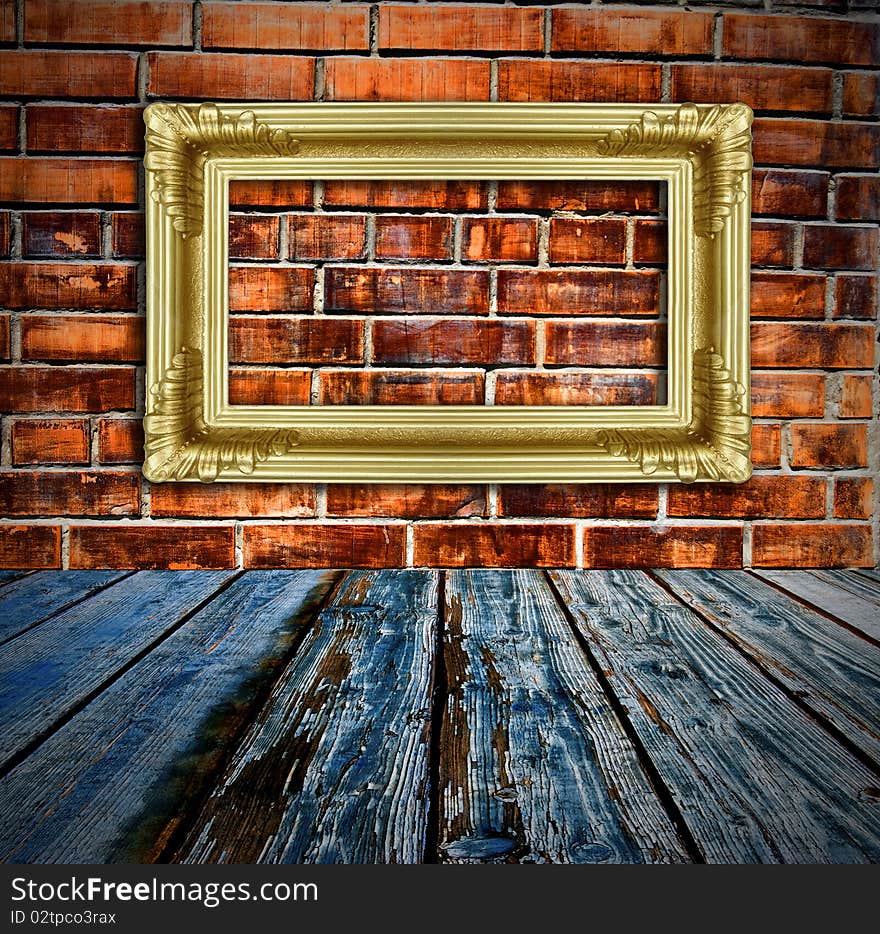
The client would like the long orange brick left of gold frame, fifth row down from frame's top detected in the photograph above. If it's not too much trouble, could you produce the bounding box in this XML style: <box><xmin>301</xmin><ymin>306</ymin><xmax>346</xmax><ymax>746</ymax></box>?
<box><xmin>21</xmin><ymin>315</ymin><xmax>145</xmax><ymax>363</ymax></box>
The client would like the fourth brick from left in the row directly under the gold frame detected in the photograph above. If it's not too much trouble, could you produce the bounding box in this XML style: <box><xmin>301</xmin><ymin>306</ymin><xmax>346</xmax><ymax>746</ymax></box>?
<box><xmin>498</xmin><ymin>483</ymin><xmax>659</xmax><ymax>519</ymax></box>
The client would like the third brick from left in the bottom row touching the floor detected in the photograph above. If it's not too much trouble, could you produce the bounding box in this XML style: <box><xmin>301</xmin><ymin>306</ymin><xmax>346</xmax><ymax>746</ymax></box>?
<box><xmin>243</xmin><ymin>522</ymin><xmax>406</xmax><ymax>568</ymax></box>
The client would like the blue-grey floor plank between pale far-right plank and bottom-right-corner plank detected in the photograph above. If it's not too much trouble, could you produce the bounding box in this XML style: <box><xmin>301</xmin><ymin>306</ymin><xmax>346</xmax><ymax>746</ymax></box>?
<box><xmin>655</xmin><ymin>571</ymin><xmax>880</xmax><ymax>763</ymax></box>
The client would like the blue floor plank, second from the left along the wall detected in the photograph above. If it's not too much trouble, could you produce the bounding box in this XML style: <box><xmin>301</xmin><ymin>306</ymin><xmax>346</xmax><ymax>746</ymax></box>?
<box><xmin>0</xmin><ymin>571</ymin><xmax>235</xmax><ymax>771</ymax></box>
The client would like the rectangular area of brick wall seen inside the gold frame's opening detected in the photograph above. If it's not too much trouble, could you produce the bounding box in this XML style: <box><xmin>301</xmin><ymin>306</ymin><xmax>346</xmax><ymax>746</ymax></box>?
<box><xmin>228</xmin><ymin>180</ymin><xmax>667</xmax><ymax>406</ymax></box>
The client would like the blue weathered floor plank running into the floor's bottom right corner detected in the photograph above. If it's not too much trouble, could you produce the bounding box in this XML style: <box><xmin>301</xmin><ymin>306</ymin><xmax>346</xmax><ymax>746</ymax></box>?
<box><xmin>552</xmin><ymin>571</ymin><xmax>880</xmax><ymax>863</ymax></box>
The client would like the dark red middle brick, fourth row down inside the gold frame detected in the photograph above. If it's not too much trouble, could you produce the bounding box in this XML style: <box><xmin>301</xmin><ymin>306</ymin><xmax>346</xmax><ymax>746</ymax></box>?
<box><xmin>373</xmin><ymin>318</ymin><xmax>535</xmax><ymax>366</ymax></box>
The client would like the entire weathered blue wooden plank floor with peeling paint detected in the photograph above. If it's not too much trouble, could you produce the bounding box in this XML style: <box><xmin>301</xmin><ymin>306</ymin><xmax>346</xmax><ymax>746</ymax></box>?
<box><xmin>0</xmin><ymin>570</ymin><xmax>880</xmax><ymax>863</ymax></box>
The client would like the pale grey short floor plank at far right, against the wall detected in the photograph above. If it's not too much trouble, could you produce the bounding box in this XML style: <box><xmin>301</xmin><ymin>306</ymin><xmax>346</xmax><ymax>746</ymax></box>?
<box><xmin>754</xmin><ymin>571</ymin><xmax>880</xmax><ymax>640</ymax></box>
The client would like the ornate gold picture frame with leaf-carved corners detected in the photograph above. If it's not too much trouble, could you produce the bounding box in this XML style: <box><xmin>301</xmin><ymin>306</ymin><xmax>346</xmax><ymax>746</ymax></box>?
<box><xmin>144</xmin><ymin>103</ymin><xmax>752</xmax><ymax>483</ymax></box>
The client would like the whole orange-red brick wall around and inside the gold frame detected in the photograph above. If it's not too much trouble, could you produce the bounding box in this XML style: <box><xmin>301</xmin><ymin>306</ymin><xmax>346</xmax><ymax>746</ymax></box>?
<box><xmin>0</xmin><ymin>0</ymin><xmax>880</xmax><ymax>567</ymax></box>
